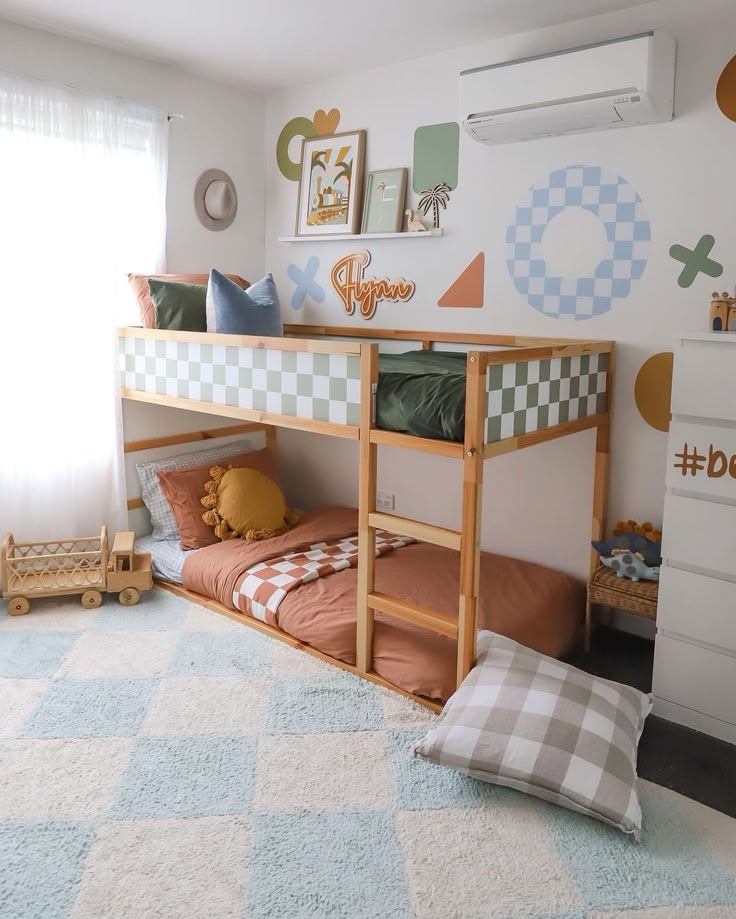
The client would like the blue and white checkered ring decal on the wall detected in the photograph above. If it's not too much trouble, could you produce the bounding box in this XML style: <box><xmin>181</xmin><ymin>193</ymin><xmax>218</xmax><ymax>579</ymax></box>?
<box><xmin>506</xmin><ymin>165</ymin><xmax>651</xmax><ymax>319</ymax></box>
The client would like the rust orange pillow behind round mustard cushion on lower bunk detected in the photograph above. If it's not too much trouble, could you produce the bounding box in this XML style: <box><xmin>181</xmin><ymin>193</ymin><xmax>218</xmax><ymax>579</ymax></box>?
<box><xmin>157</xmin><ymin>449</ymin><xmax>279</xmax><ymax>549</ymax></box>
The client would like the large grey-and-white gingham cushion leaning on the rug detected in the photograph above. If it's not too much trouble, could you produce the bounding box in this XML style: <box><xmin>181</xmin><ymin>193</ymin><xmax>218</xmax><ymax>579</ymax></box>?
<box><xmin>414</xmin><ymin>631</ymin><xmax>652</xmax><ymax>838</ymax></box>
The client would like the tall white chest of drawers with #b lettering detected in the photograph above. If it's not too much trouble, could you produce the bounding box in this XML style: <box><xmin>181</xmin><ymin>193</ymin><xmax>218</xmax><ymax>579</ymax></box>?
<box><xmin>653</xmin><ymin>332</ymin><xmax>736</xmax><ymax>743</ymax></box>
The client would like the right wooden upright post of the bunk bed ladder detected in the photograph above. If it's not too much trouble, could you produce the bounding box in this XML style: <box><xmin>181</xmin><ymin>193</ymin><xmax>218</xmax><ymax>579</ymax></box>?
<box><xmin>457</xmin><ymin>351</ymin><xmax>486</xmax><ymax>686</ymax></box>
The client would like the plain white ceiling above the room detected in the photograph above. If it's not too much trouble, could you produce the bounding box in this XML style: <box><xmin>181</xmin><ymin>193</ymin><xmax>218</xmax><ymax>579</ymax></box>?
<box><xmin>0</xmin><ymin>0</ymin><xmax>646</xmax><ymax>88</ymax></box>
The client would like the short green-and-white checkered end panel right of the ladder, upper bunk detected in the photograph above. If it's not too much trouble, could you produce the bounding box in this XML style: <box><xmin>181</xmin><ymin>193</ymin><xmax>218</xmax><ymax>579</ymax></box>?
<box><xmin>486</xmin><ymin>354</ymin><xmax>608</xmax><ymax>443</ymax></box>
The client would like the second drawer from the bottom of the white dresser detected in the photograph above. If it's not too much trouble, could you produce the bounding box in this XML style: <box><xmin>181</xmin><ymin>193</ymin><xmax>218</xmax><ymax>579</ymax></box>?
<box><xmin>657</xmin><ymin>566</ymin><xmax>736</xmax><ymax>654</ymax></box>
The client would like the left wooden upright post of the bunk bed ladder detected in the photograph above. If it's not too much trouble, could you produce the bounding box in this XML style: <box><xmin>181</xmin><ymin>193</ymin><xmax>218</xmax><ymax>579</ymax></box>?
<box><xmin>355</xmin><ymin>344</ymin><xmax>378</xmax><ymax>673</ymax></box>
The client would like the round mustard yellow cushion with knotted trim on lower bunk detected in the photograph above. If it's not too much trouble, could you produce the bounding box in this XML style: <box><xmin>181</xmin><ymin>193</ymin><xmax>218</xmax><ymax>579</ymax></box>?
<box><xmin>202</xmin><ymin>466</ymin><xmax>299</xmax><ymax>542</ymax></box>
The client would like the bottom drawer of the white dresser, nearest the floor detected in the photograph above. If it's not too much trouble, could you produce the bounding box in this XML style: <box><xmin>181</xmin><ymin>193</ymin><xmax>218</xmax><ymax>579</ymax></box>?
<box><xmin>654</xmin><ymin>635</ymin><xmax>736</xmax><ymax>724</ymax></box>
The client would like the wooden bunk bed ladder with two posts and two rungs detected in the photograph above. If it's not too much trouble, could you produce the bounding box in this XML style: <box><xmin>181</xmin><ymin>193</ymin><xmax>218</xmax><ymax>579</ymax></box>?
<box><xmin>356</xmin><ymin>345</ymin><xmax>486</xmax><ymax>686</ymax></box>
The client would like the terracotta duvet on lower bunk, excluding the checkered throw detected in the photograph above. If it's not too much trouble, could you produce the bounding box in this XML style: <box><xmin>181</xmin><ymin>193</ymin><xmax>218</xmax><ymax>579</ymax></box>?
<box><xmin>183</xmin><ymin>508</ymin><xmax>585</xmax><ymax>701</ymax></box>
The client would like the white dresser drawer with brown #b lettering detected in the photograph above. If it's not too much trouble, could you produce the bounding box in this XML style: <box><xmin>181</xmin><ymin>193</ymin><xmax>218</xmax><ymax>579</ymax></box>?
<box><xmin>666</xmin><ymin>424</ymin><xmax>736</xmax><ymax>501</ymax></box>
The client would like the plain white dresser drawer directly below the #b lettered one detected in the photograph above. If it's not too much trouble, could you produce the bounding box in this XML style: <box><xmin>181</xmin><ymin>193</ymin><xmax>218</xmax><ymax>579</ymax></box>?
<box><xmin>662</xmin><ymin>494</ymin><xmax>736</xmax><ymax>577</ymax></box>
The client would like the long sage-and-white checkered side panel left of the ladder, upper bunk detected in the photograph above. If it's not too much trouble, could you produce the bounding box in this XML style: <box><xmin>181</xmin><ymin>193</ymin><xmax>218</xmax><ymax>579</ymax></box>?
<box><xmin>119</xmin><ymin>336</ymin><xmax>360</xmax><ymax>425</ymax></box>
